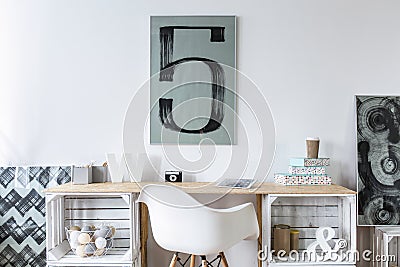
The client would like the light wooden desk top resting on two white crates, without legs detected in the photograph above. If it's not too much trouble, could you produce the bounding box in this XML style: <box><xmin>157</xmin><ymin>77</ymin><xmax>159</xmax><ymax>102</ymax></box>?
<box><xmin>43</xmin><ymin>182</ymin><xmax>356</xmax><ymax>195</ymax></box>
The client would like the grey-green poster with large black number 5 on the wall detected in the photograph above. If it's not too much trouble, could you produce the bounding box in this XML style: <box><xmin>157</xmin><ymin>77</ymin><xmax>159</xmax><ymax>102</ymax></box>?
<box><xmin>150</xmin><ymin>16</ymin><xmax>236</xmax><ymax>145</ymax></box>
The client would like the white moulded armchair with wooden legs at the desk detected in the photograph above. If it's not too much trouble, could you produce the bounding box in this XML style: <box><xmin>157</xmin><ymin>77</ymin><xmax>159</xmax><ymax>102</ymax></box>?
<box><xmin>138</xmin><ymin>184</ymin><xmax>259</xmax><ymax>267</ymax></box>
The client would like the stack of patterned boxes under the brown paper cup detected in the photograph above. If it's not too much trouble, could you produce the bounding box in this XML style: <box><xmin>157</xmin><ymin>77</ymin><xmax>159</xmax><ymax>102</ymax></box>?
<box><xmin>274</xmin><ymin>158</ymin><xmax>332</xmax><ymax>185</ymax></box>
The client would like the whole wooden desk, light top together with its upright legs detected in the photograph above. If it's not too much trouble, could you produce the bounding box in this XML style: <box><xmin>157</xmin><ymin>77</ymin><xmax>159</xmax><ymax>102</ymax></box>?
<box><xmin>44</xmin><ymin>182</ymin><xmax>356</xmax><ymax>267</ymax></box>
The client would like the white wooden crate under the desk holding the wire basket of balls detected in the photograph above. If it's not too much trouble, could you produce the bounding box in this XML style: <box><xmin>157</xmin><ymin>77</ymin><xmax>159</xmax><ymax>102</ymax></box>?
<box><xmin>46</xmin><ymin>193</ymin><xmax>139</xmax><ymax>267</ymax></box>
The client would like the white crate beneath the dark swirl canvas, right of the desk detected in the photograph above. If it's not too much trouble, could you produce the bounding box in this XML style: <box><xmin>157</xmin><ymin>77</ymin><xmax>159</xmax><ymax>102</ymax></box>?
<box><xmin>371</xmin><ymin>226</ymin><xmax>400</xmax><ymax>267</ymax></box>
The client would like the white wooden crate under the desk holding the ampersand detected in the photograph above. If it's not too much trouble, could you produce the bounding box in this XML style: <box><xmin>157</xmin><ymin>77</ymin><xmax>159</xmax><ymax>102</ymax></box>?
<box><xmin>262</xmin><ymin>194</ymin><xmax>357</xmax><ymax>267</ymax></box>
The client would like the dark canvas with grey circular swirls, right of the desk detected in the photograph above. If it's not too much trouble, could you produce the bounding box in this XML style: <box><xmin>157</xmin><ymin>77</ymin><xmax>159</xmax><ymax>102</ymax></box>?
<box><xmin>356</xmin><ymin>96</ymin><xmax>400</xmax><ymax>225</ymax></box>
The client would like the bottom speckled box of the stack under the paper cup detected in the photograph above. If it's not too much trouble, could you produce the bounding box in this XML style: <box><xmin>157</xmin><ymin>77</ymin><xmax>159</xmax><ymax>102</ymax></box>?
<box><xmin>274</xmin><ymin>173</ymin><xmax>332</xmax><ymax>185</ymax></box>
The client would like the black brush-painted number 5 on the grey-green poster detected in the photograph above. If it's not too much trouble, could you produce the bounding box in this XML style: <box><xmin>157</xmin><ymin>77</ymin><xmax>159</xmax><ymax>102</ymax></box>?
<box><xmin>159</xmin><ymin>26</ymin><xmax>225</xmax><ymax>134</ymax></box>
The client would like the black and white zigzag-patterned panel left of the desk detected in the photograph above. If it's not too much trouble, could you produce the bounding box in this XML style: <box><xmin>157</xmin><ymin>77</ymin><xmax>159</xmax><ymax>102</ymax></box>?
<box><xmin>0</xmin><ymin>166</ymin><xmax>71</xmax><ymax>267</ymax></box>
